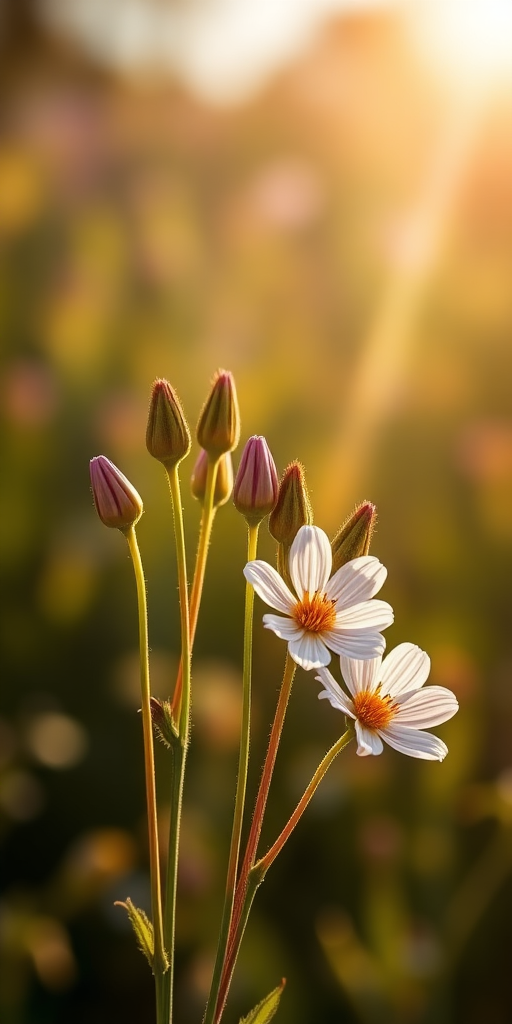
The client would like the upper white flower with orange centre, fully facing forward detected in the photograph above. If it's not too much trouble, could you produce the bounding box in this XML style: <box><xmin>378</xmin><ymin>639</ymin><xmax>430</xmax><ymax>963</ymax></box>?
<box><xmin>244</xmin><ymin>526</ymin><xmax>393</xmax><ymax>669</ymax></box>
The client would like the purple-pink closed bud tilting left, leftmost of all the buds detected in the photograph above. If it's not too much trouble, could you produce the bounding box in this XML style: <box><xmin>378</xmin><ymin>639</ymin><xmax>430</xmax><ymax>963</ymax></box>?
<box><xmin>90</xmin><ymin>455</ymin><xmax>143</xmax><ymax>530</ymax></box>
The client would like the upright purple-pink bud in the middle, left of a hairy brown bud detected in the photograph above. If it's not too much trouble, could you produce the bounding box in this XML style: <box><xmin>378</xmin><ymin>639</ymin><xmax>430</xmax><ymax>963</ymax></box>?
<box><xmin>232</xmin><ymin>436</ymin><xmax>279</xmax><ymax>525</ymax></box>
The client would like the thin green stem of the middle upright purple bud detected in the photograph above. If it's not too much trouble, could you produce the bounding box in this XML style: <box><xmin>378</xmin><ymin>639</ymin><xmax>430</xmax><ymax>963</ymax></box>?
<box><xmin>204</xmin><ymin>523</ymin><xmax>259</xmax><ymax>1024</ymax></box>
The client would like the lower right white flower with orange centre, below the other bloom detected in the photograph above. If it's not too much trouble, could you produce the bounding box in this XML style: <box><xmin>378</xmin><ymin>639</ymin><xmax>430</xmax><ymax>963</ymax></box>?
<box><xmin>316</xmin><ymin>643</ymin><xmax>459</xmax><ymax>761</ymax></box>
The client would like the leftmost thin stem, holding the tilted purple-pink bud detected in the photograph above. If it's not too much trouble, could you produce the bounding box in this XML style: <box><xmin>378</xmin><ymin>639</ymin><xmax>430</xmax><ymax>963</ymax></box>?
<box><xmin>125</xmin><ymin>526</ymin><xmax>167</xmax><ymax>1011</ymax></box>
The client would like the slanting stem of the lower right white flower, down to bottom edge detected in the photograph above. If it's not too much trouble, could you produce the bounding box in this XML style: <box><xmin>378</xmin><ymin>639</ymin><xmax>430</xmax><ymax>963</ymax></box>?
<box><xmin>215</xmin><ymin>728</ymin><xmax>353</xmax><ymax>1024</ymax></box>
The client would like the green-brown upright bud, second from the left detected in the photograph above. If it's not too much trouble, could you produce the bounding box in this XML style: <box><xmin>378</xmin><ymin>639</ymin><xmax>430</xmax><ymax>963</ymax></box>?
<box><xmin>145</xmin><ymin>379</ymin><xmax>190</xmax><ymax>468</ymax></box>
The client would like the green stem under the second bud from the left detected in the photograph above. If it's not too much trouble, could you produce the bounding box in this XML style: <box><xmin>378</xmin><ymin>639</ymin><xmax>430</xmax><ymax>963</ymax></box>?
<box><xmin>164</xmin><ymin>466</ymin><xmax>190</xmax><ymax>1022</ymax></box>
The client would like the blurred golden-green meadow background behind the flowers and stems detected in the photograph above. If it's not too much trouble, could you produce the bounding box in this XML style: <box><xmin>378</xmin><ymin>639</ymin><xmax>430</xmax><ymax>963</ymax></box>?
<box><xmin>0</xmin><ymin>0</ymin><xmax>512</xmax><ymax>1024</ymax></box>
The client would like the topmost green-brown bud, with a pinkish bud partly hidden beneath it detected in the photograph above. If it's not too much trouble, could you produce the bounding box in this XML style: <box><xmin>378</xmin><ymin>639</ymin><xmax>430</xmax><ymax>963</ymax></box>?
<box><xmin>197</xmin><ymin>370</ymin><xmax>240</xmax><ymax>459</ymax></box>
